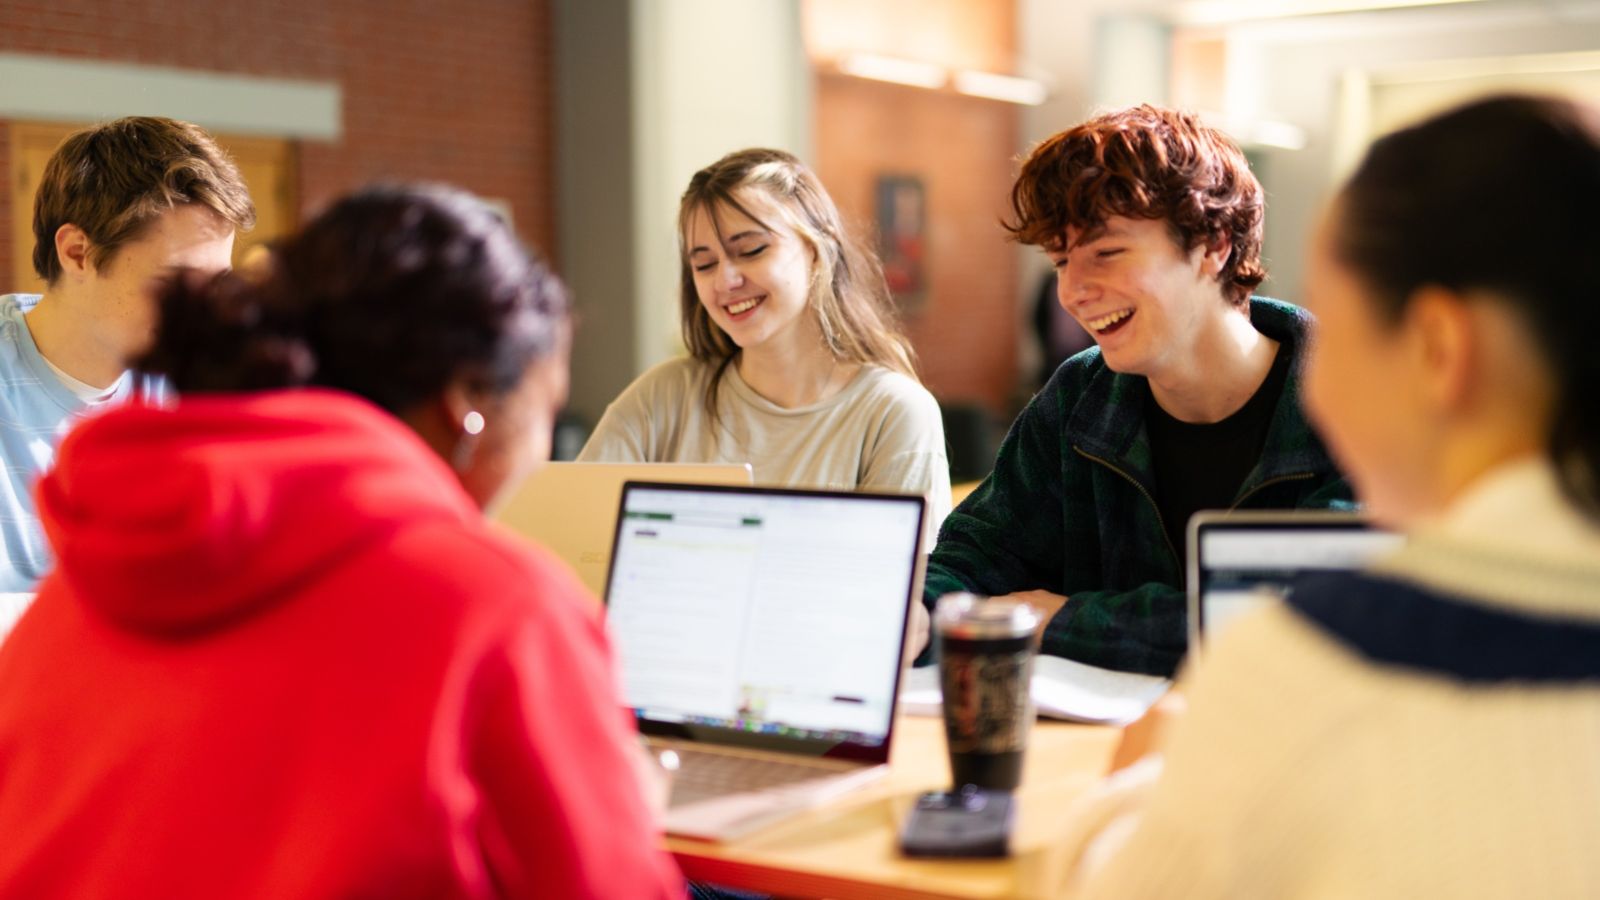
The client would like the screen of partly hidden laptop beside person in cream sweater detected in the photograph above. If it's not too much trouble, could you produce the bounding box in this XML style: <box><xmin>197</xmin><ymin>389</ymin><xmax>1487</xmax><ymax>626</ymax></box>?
<box><xmin>1200</xmin><ymin>525</ymin><xmax>1402</xmax><ymax>637</ymax></box>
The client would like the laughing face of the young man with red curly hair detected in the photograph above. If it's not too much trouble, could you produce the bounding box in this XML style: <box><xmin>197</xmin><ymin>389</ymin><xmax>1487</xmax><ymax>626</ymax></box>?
<box><xmin>1050</xmin><ymin>216</ymin><xmax>1230</xmax><ymax>378</ymax></box>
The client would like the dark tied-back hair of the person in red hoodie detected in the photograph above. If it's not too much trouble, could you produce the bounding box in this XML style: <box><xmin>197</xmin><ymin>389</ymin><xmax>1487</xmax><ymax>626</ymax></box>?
<box><xmin>138</xmin><ymin>186</ymin><xmax>568</xmax><ymax>413</ymax></box>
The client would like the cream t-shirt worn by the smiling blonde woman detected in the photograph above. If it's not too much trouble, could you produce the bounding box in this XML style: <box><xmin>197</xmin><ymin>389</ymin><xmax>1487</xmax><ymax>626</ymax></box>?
<box><xmin>578</xmin><ymin>357</ymin><xmax>950</xmax><ymax>538</ymax></box>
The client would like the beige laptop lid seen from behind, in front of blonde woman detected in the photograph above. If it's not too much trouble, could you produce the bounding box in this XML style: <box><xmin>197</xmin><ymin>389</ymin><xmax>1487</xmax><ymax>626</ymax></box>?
<box><xmin>494</xmin><ymin>463</ymin><xmax>754</xmax><ymax>597</ymax></box>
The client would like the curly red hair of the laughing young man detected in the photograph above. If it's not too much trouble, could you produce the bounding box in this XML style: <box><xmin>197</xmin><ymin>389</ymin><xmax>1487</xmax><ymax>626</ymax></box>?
<box><xmin>1000</xmin><ymin>104</ymin><xmax>1267</xmax><ymax>306</ymax></box>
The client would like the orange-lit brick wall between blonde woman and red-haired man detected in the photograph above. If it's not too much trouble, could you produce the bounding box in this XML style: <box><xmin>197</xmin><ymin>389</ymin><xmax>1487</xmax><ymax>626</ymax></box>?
<box><xmin>802</xmin><ymin>0</ymin><xmax>1021</xmax><ymax>418</ymax></box>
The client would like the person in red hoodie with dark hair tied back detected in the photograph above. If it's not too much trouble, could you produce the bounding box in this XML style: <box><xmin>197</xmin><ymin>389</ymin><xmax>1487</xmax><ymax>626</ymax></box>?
<box><xmin>0</xmin><ymin>187</ymin><xmax>683</xmax><ymax>900</ymax></box>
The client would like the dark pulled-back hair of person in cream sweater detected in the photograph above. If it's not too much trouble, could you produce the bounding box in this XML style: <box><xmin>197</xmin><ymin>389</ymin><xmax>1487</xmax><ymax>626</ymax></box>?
<box><xmin>1334</xmin><ymin>96</ymin><xmax>1600</xmax><ymax>519</ymax></box>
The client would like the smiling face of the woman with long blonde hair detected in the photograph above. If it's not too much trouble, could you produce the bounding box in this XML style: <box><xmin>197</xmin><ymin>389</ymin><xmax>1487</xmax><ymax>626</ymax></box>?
<box><xmin>683</xmin><ymin>189</ymin><xmax>819</xmax><ymax>351</ymax></box>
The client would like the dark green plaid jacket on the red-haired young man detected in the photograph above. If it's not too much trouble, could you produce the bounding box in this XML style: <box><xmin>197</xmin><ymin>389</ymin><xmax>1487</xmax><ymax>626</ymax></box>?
<box><xmin>922</xmin><ymin>298</ymin><xmax>1354</xmax><ymax>676</ymax></box>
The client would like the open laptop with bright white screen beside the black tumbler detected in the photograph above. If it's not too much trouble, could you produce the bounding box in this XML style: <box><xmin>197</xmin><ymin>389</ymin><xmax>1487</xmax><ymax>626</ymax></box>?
<box><xmin>606</xmin><ymin>482</ymin><xmax>926</xmax><ymax>839</ymax></box>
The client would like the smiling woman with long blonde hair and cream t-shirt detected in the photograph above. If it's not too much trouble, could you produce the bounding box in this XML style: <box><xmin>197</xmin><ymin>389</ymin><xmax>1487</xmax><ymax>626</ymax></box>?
<box><xmin>579</xmin><ymin>149</ymin><xmax>950</xmax><ymax>546</ymax></box>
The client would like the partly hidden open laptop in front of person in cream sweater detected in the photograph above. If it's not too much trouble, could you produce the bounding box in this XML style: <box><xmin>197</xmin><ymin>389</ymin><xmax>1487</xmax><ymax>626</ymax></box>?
<box><xmin>1189</xmin><ymin>509</ymin><xmax>1403</xmax><ymax>652</ymax></box>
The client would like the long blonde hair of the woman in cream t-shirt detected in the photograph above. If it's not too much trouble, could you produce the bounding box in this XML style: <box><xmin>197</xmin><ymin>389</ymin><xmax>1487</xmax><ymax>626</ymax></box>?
<box><xmin>678</xmin><ymin>147</ymin><xmax>917</xmax><ymax>416</ymax></box>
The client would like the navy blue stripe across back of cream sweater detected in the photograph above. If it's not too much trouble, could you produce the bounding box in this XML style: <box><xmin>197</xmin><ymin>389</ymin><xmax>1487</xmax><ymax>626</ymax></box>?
<box><xmin>1288</xmin><ymin>573</ymin><xmax>1600</xmax><ymax>684</ymax></box>
